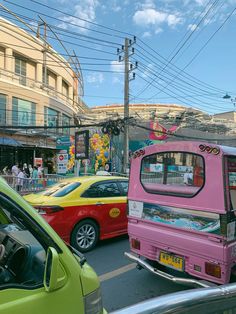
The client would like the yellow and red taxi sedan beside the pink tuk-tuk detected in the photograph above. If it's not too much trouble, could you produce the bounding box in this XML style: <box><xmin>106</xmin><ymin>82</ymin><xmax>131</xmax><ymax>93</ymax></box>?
<box><xmin>24</xmin><ymin>176</ymin><xmax>128</xmax><ymax>252</ymax></box>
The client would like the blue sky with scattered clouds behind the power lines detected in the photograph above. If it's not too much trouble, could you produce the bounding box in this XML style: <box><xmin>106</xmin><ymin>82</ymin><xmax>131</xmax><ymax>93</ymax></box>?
<box><xmin>0</xmin><ymin>0</ymin><xmax>236</xmax><ymax>114</ymax></box>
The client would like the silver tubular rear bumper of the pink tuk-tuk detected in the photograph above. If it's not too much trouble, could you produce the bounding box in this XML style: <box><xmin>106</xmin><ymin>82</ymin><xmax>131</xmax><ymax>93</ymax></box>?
<box><xmin>124</xmin><ymin>252</ymin><xmax>216</xmax><ymax>288</ymax></box>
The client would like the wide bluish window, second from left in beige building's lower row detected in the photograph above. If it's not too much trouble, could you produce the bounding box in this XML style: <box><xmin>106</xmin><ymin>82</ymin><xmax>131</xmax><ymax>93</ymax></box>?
<box><xmin>12</xmin><ymin>97</ymin><xmax>36</xmax><ymax>126</ymax></box>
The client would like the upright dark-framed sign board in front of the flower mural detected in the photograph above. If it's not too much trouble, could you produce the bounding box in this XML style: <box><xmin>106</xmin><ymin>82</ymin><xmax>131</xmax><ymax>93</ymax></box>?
<box><xmin>75</xmin><ymin>130</ymin><xmax>89</xmax><ymax>159</ymax></box>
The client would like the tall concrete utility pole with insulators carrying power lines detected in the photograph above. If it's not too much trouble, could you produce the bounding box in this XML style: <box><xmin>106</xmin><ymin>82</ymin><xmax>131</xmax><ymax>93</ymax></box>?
<box><xmin>117</xmin><ymin>37</ymin><xmax>138</xmax><ymax>173</ymax></box>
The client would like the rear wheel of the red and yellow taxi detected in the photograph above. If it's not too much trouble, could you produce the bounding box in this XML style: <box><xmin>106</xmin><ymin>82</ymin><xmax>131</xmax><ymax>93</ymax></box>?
<box><xmin>71</xmin><ymin>219</ymin><xmax>99</xmax><ymax>252</ymax></box>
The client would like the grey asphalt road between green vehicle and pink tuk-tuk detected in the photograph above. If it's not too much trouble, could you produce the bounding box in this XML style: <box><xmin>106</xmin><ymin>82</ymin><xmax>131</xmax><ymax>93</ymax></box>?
<box><xmin>85</xmin><ymin>236</ymin><xmax>188</xmax><ymax>312</ymax></box>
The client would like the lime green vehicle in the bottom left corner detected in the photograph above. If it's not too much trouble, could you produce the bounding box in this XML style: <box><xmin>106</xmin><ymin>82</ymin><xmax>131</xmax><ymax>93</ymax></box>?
<box><xmin>0</xmin><ymin>178</ymin><xmax>106</xmax><ymax>314</ymax></box>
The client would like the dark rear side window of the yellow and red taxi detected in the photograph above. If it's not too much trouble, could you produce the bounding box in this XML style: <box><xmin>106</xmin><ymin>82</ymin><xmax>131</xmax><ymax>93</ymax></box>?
<box><xmin>82</xmin><ymin>182</ymin><xmax>121</xmax><ymax>198</ymax></box>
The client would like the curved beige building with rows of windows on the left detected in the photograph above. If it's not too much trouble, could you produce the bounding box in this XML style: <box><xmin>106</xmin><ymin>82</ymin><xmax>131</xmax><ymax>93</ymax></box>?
<box><xmin>0</xmin><ymin>18</ymin><xmax>88</xmax><ymax>170</ymax></box>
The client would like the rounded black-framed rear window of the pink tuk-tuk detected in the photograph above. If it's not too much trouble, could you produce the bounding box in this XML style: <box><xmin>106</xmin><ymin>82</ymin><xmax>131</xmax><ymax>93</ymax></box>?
<box><xmin>140</xmin><ymin>152</ymin><xmax>205</xmax><ymax>197</ymax></box>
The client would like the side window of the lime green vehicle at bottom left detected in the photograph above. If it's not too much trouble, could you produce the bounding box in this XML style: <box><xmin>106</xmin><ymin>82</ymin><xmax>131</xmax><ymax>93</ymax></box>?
<box><xmin>0</xmin><ymin>193</ymin><xmax>49</xmax><ymax>290</ymax></box>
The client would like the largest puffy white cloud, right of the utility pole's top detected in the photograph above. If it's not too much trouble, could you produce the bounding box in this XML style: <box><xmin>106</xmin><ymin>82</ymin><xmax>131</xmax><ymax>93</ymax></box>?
<box><xmin>133</xmin><ymin>9</ymin><xmax>182</xmax><ymax>27</ymax></box>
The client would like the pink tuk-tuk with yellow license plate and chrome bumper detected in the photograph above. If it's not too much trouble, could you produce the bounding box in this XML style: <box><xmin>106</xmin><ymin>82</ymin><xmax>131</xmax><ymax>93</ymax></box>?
<box><xmin>125</xmin><ymin>141</ymin><xmax>236</xmax><ymax>287</ymax></box>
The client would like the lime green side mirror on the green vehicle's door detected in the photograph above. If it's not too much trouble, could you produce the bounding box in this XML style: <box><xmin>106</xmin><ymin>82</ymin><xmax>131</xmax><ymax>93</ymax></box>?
<box><xmin>43</xmin><ymin>247</ymin><xmax>67</xmax><ymax>292</ymax></box>
